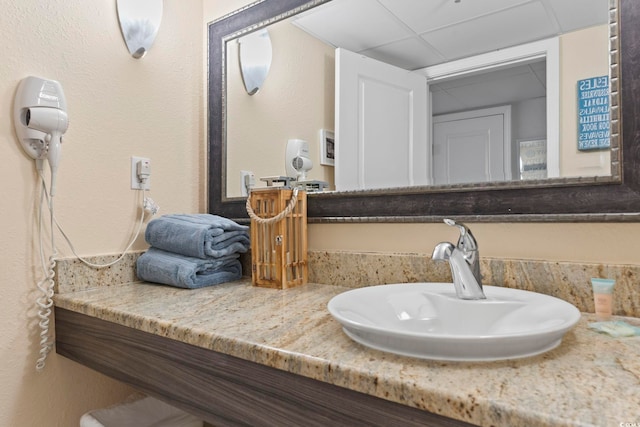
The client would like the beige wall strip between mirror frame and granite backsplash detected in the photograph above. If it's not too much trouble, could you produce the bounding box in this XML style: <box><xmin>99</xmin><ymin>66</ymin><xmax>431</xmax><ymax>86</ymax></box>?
<box><xmin>309</xmin><ymin>223</ymin><xmax>640</xmax><ymax>266</ymax></box>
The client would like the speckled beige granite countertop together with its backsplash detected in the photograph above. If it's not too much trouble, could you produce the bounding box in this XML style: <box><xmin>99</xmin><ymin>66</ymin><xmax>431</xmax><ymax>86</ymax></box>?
<box><xmin>55</xmin><ymin>251</ymin><xmax>640</xmax><ymax>426</ymax></box>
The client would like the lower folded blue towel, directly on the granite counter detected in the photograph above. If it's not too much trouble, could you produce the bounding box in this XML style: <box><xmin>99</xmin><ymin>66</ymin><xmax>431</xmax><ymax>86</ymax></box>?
<box><xmin>136</xmin><ymin>247</ymin><xmax>242</xmax><ymax>289</ymax></box>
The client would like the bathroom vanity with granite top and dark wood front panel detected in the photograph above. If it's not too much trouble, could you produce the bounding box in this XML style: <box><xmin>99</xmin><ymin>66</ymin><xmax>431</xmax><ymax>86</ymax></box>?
<box><xmin>55</xmin><ymin>280</ymin><xmax>640</xmax><ymax>427</ymax></box>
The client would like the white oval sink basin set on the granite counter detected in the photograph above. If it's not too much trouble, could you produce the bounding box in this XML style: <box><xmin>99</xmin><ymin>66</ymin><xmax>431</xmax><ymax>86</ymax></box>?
<box><xmin>328</xmin><ymin>283</ymin><xmax>580</xmax><ymax>361</ymax></box>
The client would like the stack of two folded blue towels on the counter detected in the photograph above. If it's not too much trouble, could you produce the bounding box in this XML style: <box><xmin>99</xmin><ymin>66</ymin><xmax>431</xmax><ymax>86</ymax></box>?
<box><xmin>137</xmin><ymin>214</ymin><xmax>250</xmax><ymax>288</ymax></box>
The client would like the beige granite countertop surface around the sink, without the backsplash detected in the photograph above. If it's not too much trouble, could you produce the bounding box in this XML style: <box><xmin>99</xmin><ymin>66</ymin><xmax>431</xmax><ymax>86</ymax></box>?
<box><xmin>55</xmin><ymin>281</ymin><xmax>640</xmax><ymax>426</ymax></box>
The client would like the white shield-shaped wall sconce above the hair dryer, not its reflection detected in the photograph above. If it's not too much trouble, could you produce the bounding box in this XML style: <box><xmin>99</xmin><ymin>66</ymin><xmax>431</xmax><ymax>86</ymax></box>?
<box><xmin>116</xmin><ymin>0</ymin><xmax>163</xmax><ymax>59</ymax></box>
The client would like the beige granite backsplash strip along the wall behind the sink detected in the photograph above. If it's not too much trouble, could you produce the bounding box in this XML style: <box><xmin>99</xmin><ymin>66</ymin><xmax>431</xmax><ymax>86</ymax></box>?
<box><xmin>56</xmin><ymin>251</ymin><xmax>640</xmax><ymax>317</ymax></box>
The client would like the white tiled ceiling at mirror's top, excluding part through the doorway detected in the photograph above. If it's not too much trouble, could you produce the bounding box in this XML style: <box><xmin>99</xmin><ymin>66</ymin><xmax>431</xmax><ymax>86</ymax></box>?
<box><xmin>295</xmin><ymin>0</ymin><xmax>608</xmax><ymax>70</ymax></box>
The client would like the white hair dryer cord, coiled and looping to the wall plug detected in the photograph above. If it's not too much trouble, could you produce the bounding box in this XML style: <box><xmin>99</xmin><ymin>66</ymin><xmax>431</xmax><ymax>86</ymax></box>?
<box><xmin>36</xmin><ymin>171</ymin><xmax>158</xmax><ymax>372</ymax></box>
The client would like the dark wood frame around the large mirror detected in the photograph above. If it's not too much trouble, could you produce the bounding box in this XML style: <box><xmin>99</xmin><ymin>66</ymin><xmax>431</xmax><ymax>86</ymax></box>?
<box><xmin>208</xmin><ymin>0</ymin><xmax>640</xmax><ymax>222</ymax></box>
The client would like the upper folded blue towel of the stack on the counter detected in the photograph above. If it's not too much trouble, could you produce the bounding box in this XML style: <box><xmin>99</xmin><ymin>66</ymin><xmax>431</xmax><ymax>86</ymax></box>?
<box><xmin>145</xmin><ymin>214</ymin><xmax>250</xmax><ymax>259</ymax></box>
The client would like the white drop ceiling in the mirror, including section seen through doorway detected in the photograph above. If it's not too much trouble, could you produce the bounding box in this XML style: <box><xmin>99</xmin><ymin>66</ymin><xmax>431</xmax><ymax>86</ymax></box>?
<box><xmin>293</xmin><ymin>0</ymin><xmax>609</xmax><ymax>114</ymax></box>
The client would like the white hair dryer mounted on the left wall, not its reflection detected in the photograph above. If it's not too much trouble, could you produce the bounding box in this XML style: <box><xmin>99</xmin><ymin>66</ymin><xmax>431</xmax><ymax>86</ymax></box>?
<box><xmin>13</xmin><ymin>76</ymin><xmax>69</xmax><ymax>196</ymax></box>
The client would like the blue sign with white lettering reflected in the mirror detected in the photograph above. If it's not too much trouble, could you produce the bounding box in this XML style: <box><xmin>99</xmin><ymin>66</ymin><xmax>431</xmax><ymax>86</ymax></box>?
<box><xmin>578</xmin><ymin>76</ymin><xmax>611</xmax><ymax>151</ymax></box>
